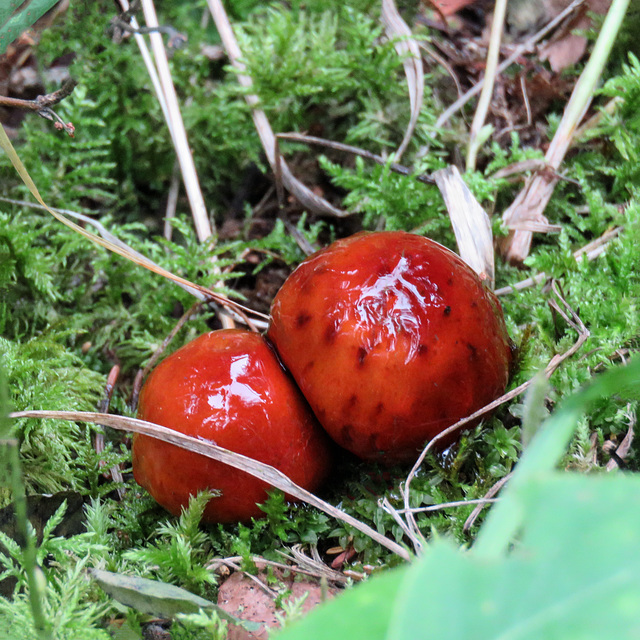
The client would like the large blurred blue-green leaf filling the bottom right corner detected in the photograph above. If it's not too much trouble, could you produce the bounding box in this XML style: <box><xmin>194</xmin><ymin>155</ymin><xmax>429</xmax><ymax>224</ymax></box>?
<box><xmin>390</xmin><ymin>473</ymin><xmax>640</xmax><ymax>640</ymax></box>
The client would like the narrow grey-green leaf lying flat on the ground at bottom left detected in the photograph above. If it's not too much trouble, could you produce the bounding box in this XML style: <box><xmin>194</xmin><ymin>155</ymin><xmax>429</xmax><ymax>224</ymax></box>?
<box><xmin>90</xmin><ymin>569</ymin><xmax>260</xmax><ymax>631</ymax></box>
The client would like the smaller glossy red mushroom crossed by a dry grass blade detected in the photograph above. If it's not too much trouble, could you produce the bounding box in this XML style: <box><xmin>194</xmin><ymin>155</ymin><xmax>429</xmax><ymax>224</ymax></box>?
<box><xmin>133</xmin><ymin>329</ymin><xmax>330</xmax><ymax>522</ymax></box>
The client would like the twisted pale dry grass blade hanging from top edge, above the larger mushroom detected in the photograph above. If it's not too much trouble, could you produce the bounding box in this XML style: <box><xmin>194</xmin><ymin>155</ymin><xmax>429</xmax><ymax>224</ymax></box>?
<box><xmin>381</xmin><ymin>0</ymin><xmax>424</xmax><ymax>160</ymax></box>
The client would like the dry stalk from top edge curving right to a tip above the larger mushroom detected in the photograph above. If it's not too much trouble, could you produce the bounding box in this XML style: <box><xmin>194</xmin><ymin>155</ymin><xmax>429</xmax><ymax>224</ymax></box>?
<box><xmin>207</xmin><ymin>0</ymin><xmax>348</xmax><ymax>218</ymax></box>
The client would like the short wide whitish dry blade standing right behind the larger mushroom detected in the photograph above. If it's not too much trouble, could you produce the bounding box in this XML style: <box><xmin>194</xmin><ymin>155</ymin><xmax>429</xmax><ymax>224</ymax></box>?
<box><xmin>433</xmin><ymin>166</ymin><xmax>495</xmax><ymax>287</ymax></box>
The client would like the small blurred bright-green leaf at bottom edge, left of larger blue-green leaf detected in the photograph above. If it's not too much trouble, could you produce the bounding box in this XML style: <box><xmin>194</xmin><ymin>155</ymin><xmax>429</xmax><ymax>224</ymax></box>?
<box><xmin>275</xmin><ymin>568</ymin><xmax>406</xmax><ymax>640</ymax></box>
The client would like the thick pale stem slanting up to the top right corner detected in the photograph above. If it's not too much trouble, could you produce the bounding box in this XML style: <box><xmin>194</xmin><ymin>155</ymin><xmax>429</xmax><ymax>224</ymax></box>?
<box><xmin>501</xmin><ymin>0</ymin><xmax>629</xmax><ymax>264</ymax></box>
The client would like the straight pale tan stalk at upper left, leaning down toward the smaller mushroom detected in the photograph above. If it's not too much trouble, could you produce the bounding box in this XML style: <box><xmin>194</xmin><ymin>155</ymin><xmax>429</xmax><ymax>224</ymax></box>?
<box><xmin>137</xmin><ymin>0</ymin><xmax>213</xmax><ymax>242</ymax></box>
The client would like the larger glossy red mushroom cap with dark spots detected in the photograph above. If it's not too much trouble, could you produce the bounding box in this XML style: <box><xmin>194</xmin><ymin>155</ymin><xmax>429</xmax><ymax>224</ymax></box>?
<box><xmin>267</xmin><ymin>231</ymin><xmax>511</xmax><ymax>463</ymax></box>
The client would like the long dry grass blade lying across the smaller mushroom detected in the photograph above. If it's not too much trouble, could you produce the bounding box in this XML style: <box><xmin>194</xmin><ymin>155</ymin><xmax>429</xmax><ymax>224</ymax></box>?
<box><xmin>10</xmin><ymin>411</ymin><xmax>411</xmax><ymax>560</ymax></box>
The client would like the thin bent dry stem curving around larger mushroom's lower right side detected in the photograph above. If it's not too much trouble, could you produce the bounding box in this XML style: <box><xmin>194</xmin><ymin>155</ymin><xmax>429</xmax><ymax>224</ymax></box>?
<box><xmin>401</xmin><ymin>282</ymin><xmax>590</xmax><ymax>553</ymax></box>
